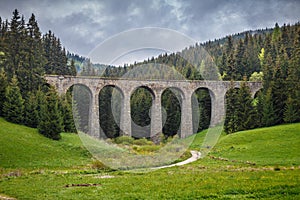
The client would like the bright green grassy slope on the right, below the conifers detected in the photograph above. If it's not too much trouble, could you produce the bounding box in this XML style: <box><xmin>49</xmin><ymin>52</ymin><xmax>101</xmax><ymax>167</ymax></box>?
<box><xmin>211</xmin><ymin>124</ymin><xmax>300</xmax><ymax>166</ymax></box>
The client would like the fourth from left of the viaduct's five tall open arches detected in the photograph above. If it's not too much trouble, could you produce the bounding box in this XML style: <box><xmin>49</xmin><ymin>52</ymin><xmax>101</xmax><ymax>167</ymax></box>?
<box><xmin>161</xmin><ymin>87</ymin><xmax>185</xmax><ymax>136</ymax></box>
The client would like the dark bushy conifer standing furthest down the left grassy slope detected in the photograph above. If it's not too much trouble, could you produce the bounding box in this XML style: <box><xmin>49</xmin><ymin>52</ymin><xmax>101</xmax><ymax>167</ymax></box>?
<box><xmin>38</xmin><ymin>87</ymin><xmax>64</xmax><ymax>140</ymax></box>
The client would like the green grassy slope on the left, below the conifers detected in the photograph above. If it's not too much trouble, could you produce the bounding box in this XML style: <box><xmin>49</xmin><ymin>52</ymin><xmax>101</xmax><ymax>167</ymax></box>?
<box><xmin>0</xmin><ymin>118</ymin><xmax>91</xmax><ymax>169</ymax></box>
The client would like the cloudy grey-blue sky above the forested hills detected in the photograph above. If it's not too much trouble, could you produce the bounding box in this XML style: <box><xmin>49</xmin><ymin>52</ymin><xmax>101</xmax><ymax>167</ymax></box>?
<box><xmin>0</xmin><ymin>0</ymin><xmax>300</xmax><ymax>63</ymax></box>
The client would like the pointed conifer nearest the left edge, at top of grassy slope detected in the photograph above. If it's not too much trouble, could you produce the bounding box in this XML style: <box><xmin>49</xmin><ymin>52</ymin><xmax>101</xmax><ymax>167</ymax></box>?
<box><xmin>3</xmin><ymin>76</ymin><xmax>24</xmax><ymax>124</ymax></box>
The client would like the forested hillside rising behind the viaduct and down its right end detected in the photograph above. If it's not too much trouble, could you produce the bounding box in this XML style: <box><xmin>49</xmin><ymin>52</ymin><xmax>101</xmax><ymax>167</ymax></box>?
<box><xmin>80</xmin><ymin>23</ymin><xmax>300</xmax><ymax>138</ymax></box>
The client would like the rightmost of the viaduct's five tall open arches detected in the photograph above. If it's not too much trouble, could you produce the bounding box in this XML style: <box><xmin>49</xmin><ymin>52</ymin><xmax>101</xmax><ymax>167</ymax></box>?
<box><xmin>191</xmin><ymin>87</ymin><xmax>216</xmax><ymax>133</ymax></box>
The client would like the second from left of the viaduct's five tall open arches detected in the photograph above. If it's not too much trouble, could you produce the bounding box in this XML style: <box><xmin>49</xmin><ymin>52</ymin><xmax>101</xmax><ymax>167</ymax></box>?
<box><xmin>98</xmin><ymin>84</ymin><xmax>124</xmax><ymax>138</ymax></box>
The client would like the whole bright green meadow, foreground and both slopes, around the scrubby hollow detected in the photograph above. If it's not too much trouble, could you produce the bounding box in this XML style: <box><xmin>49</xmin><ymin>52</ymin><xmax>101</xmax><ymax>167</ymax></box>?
<box><xmin>0</xmin><ymin>119</ymin><xmax>300</xmax><ymax>199</ymax></box>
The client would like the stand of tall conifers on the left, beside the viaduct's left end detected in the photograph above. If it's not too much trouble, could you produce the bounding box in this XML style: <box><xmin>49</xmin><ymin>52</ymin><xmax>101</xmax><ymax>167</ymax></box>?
<box><xmin>0</xmin><ymin>10</ymin><xmax>76</xmax><ymax>140</ymax></box>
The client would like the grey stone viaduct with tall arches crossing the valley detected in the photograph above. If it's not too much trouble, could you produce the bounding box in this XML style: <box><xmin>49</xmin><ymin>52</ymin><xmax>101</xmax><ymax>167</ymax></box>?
<box><xmin>45</xmin><ymin>75</ymin><xmax>262</xmax><ymax>138</ymax></box>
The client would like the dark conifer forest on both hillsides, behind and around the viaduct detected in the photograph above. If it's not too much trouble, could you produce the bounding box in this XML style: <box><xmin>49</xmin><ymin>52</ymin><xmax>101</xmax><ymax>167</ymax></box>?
<box><xmin>0</xmin><ymin>10</ymin><xmax>300</xmax><ymax>139</ymax></box>
